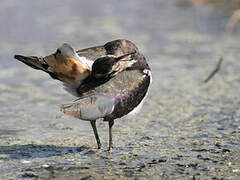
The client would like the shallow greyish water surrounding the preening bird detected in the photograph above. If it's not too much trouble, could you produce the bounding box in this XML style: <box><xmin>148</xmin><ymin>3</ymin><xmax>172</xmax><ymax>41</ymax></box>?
<box><xmin>0</xmin><ymin>0</ymin><xmax>240</xmax><ymax>179</ymax></box>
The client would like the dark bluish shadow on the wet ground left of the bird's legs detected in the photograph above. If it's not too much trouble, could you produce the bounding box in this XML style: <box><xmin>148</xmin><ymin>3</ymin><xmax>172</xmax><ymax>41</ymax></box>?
<box><xmin>0</xmin><ymin>144</ymin><xmax>89</xmax><ymax>160</ymax></box>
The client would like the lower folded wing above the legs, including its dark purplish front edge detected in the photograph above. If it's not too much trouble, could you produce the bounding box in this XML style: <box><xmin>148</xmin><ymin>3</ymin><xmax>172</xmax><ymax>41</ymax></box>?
<box><xmin>62</xmin><ymin>53</ymin><xmax>151</xmax><ymax>120</ymax></box>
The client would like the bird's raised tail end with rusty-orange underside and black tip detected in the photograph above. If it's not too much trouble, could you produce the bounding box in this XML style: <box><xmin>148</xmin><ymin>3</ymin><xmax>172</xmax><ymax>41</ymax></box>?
<box><xmin>15</xmin><ymin>43</ymin><xmax>91</xmax><ymax>84</ymax></box>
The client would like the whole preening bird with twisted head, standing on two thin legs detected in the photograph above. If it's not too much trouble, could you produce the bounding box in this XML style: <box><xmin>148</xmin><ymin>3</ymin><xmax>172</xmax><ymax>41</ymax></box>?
<box><xmin>14</xmin><ymin>39</ymin><xmax>152</xmax><ymax>151</ymax></box>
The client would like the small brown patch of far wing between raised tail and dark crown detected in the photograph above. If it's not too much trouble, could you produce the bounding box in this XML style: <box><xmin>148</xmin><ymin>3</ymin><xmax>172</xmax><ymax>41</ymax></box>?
<box><xmin>76</xmin><ymin>46</ymin><xmax>107</xmax><ymax>61</ymax></box>
